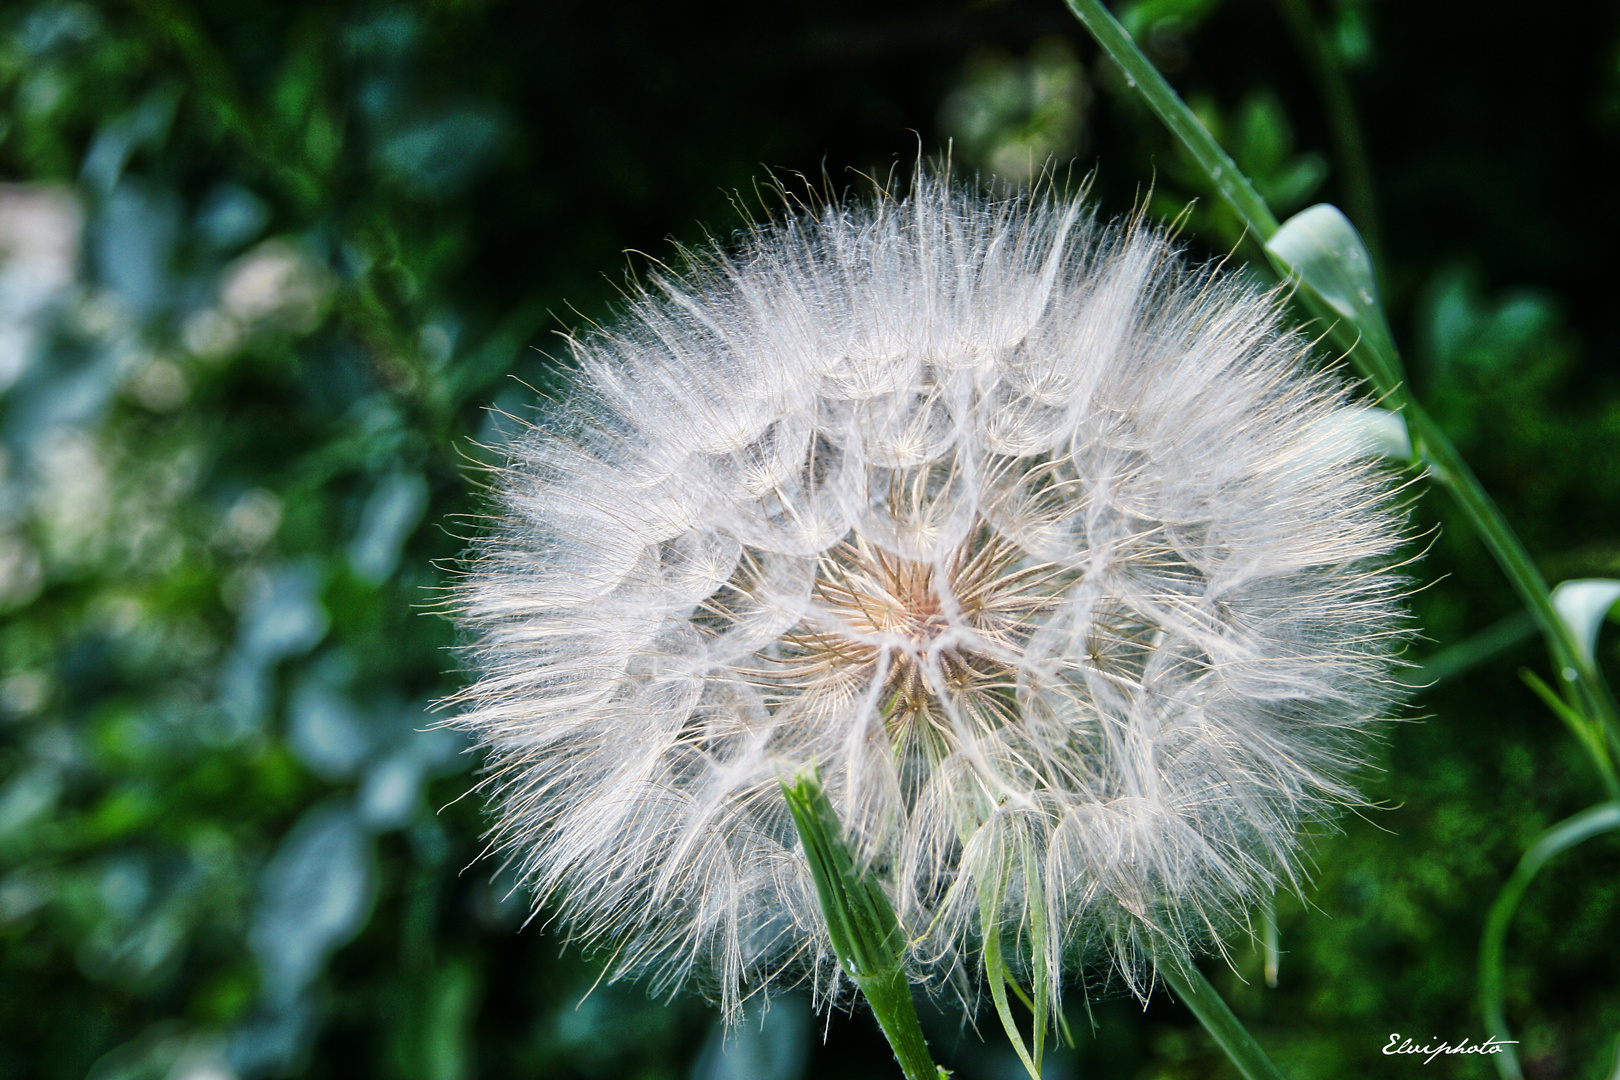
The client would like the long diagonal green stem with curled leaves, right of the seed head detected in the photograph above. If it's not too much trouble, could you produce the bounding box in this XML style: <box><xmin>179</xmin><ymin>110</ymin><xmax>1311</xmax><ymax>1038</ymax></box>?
<box><xmin>1066</xmin><ymin>0</ymin><xmax>1620</xmax><ymax>767</ymax></box>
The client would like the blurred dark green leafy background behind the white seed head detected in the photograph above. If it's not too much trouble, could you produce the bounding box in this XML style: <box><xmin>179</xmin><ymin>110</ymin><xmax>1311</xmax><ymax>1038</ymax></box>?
<box><xmin>0</xmin><ymin>0</ymin><xmax>1620</xmax><ymax>1080</ymax></box>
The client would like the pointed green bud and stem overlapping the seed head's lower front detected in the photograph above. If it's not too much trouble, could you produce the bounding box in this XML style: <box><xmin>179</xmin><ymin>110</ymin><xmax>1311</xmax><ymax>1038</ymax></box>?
<box><xmin>781</xmin><ymin>769</ymin><xmax>946</xmax><ymax>1080</ymax></box>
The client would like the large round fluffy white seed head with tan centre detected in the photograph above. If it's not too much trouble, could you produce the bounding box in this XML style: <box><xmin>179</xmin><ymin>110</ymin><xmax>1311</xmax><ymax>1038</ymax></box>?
<box><xmin>457</xmin><ymin>181</ymin><xmax>1403</xmax><ymax>1010</ymax></box>
